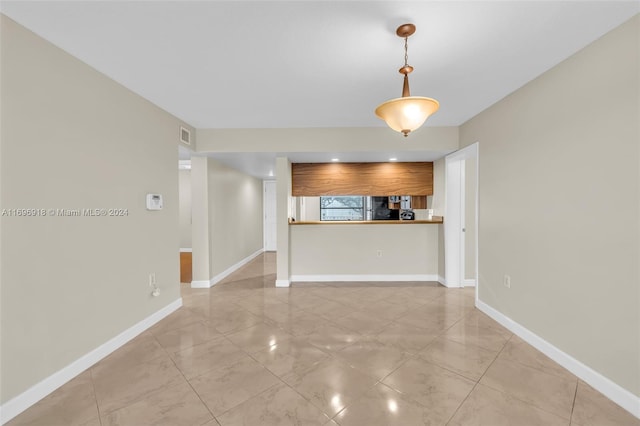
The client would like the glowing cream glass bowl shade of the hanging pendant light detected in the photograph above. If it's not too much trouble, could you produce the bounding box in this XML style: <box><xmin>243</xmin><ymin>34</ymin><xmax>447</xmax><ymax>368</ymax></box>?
<box><xmin>376</xmin><ymin>96</ymin><xmax>440</xmax><ymax>136</ymax></box>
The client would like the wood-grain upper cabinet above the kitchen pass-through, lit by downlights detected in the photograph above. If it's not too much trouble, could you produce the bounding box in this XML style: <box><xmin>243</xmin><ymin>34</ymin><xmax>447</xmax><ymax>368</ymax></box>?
<box><xmin>291</xmin><ymin>162</ymin><xmax>433</xmax><ymax>197</ymax></box>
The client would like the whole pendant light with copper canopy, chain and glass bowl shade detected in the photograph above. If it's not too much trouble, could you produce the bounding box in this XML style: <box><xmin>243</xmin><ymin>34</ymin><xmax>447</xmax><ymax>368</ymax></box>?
<box><xmin>376</xmin><ymin>24</ymin><xmax>440</xmax><ymax>137</ymax></box>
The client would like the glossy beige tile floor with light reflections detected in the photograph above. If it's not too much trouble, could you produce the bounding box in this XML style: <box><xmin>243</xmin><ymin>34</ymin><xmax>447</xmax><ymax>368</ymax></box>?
<box><xmin>9</xmin><ymin>253</ymin><xmax>640</xmax><ymax>426</ymax></box>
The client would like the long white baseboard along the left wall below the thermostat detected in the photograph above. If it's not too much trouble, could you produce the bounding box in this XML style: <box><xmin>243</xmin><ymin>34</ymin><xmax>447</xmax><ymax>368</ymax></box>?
<box><xmin>0</xmin><ymin>298</ymin><xmax>182</xmax><ymax>424</ymax></box>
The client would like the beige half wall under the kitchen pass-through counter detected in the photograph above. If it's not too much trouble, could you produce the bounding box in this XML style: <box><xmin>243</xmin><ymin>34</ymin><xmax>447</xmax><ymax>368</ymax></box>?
<box><xmin>289</xmin><ymin>224</ymin><xmax>438</xmax><ymax>276</ymax></box>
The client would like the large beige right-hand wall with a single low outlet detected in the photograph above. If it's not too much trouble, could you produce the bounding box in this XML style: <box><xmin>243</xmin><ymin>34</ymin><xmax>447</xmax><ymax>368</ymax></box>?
<box><xmin>460</xmin><ymin>16</ymin><xmax>640</xmax><ymax>395</ymax></box>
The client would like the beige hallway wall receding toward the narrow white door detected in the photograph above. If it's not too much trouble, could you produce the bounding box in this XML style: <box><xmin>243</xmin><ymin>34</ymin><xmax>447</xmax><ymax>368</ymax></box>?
<box><xmin>207</xmin><ymin>158</ymin><xmax>263</xmax><ymax>277</ymax></box>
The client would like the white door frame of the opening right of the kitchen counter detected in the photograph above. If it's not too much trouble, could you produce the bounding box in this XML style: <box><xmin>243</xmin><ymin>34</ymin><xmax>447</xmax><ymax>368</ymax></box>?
<box><xmin>444</xmin><ymin>142</ymin><xmax>479</xmax><ymax>292</ymax></box>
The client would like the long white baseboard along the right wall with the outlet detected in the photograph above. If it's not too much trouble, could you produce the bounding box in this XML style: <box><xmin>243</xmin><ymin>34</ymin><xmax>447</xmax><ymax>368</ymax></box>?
<box><xmin>476</xmin><ymin>300</ymin><xmax>640</xmax><ymax>418</ymax></box>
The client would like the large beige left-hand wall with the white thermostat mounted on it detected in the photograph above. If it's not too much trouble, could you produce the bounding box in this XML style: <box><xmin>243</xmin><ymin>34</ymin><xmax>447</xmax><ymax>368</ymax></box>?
<box><xmin>0</xmin><ymin>16</ymin><xmax>189</xmax><ymax>403</ymax></box>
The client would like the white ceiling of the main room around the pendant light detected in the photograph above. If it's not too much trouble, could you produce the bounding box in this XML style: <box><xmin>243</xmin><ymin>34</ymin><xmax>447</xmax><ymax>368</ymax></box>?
<box><xmin>0</xmin><ymin>0</ymin><xmax>640</xmax><ymax>177</ymax></box>
